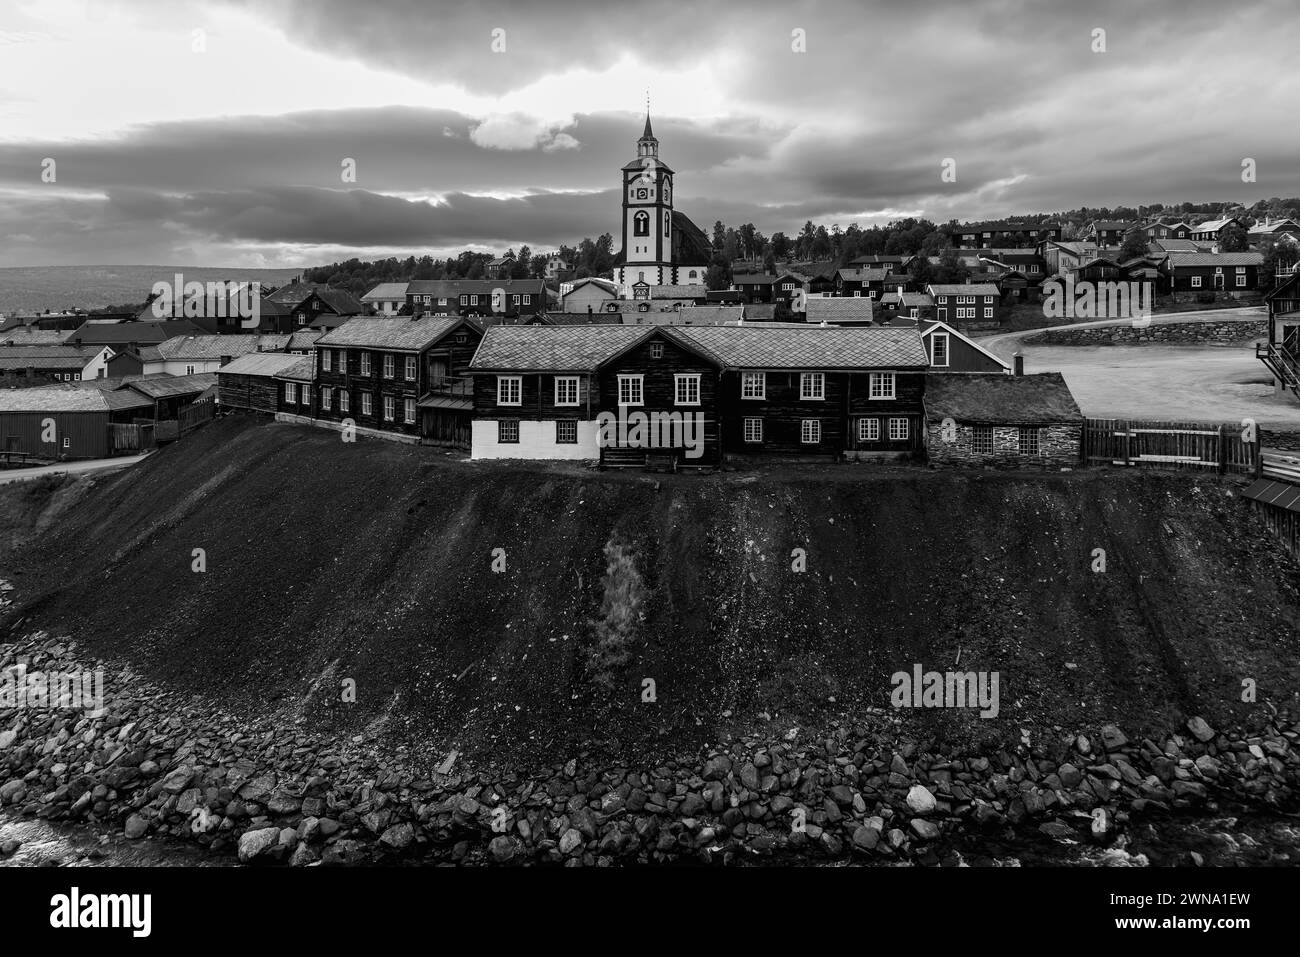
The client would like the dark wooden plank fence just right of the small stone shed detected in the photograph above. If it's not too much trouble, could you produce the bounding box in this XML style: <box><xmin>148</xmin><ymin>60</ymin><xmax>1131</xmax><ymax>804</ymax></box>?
<box><xmin>1083</xmin><ymin>419</ymin><xmax>1260</xmax><ymax>475</ymax></box>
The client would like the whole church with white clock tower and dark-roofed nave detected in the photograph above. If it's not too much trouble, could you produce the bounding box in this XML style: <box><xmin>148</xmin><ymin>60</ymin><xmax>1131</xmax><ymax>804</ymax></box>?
<box><xmin>614</xmin><ymin>111</ymin><xmax>712</xmax><ymax>299</ymax></box>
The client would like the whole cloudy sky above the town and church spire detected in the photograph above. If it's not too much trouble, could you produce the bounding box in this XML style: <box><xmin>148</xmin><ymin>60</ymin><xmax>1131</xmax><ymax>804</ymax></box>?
<box><xmin>0</xmin><ymin>0</ymin><xmax>1300</xmax><ymax>267</ymax></box>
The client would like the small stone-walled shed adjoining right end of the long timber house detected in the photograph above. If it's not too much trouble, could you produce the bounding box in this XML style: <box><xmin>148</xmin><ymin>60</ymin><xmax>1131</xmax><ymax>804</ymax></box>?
<box><xmin>926</xmin><ymin>372</ymin><xmax>1083</xmax><ymax>468</ymax></box>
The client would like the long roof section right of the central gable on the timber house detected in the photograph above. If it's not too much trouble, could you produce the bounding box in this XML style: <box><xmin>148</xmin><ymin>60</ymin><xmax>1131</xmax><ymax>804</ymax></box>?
<box><xmin>671</xmin><ymin>325</ymin><xmax>930</xmax><ymax>369</ymax></box>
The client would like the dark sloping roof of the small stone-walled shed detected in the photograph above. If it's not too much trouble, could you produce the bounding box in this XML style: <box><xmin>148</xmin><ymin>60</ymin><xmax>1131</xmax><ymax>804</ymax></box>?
<box><xmin>926</xmin><ymin>372</ymin><xmax>1083</xmax><ymax>425</ymax></box>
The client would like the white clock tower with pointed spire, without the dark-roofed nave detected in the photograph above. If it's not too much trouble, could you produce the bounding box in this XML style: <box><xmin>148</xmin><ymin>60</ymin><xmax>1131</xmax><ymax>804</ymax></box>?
<box><xmin>621</xmin><ymin>108</ymin><xmax>673</xmax><ymax>286</ymax></box>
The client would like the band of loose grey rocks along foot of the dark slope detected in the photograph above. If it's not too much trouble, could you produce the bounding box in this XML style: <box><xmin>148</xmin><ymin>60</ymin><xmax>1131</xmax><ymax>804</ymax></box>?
<box><xmin>0</xmin><ymin>632</ymin><xmax>1300</xmax><ymax>866</ymax></box>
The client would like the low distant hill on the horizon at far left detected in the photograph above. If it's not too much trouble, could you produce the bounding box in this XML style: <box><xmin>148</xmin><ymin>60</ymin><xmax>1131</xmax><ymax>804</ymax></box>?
<box><xmin>0</xmin><ymin>265</ymin><xmax>302</xmax><ymax>316</ymax></box>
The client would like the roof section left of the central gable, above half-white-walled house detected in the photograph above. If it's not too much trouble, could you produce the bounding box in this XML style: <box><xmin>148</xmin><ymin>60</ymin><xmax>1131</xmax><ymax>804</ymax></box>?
<box><xmin>469</xmin><ymin>325</ymin><xmax>646</xmax><ymax>372</ymax></box>
